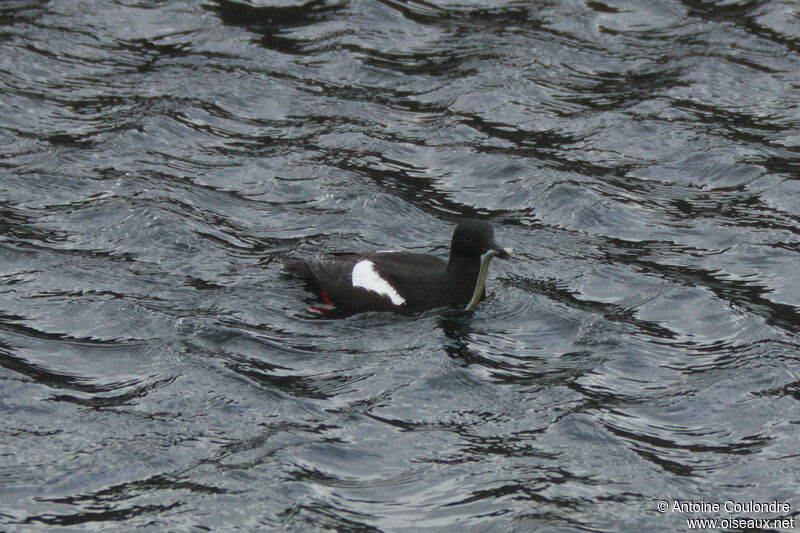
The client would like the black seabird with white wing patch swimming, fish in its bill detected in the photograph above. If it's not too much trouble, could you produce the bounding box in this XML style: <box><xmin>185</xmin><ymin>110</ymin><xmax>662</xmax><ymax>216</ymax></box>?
<box><xmin>283</xmin><ymin>220</ymin><xmax>513</xmax><ymax>312</ymax></box>
